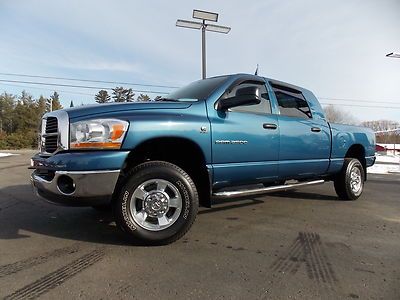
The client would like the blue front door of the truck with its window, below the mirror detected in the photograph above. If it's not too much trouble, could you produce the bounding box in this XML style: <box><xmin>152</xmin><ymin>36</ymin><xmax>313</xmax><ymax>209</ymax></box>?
<box><xmin>210</xmin><ymin>82</ymin><xmax>279</xmax><ymax>188</ymax></box>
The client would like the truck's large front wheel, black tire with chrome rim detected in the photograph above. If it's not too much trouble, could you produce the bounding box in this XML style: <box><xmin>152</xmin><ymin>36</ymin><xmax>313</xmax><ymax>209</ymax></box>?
<box><xmin>113</xmin><ymin>161</ymin><xmax>199</xmax><ymax>245</ymax></box>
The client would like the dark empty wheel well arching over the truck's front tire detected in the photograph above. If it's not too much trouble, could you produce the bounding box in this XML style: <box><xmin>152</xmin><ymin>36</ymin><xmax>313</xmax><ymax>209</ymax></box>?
<box><xmin>113</xmin><ymin>137</ymin><xmax>211</xmax><ymax>207</ymax></box>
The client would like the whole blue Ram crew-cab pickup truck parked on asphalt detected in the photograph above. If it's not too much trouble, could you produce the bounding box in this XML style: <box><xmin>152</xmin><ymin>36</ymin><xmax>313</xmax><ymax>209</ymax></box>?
<box><xmin>31</xmin><ymin>74</ymin><xmax>375</xmax><ymax>244</ymax></box>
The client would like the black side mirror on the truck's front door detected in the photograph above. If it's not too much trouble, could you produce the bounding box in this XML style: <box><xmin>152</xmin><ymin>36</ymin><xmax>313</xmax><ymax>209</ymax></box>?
<box><xmin>217</xmin><ymin>86</ymin><xmax>261</xmax><ymax>110</ymax></box>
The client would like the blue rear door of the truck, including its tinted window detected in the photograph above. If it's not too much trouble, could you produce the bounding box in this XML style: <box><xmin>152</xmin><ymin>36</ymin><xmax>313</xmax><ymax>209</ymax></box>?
<box><xmin>271</xmin><ymin>83</ymin><xmax>331</xmax><ymax>179</ymax></box>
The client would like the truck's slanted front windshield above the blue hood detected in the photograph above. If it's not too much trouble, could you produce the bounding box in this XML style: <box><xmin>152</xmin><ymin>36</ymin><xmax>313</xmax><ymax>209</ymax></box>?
<box><xmin>161</xmin><ymin>76</ymin><xmax>228</xmax><ymax>102</ymax></box>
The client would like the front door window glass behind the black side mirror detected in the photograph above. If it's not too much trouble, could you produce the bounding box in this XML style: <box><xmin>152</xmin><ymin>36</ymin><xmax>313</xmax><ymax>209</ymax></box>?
<box><xmin>224</xmin><ymin>82</ymin><xmax>271</xmax><ymax>114</ymax></box>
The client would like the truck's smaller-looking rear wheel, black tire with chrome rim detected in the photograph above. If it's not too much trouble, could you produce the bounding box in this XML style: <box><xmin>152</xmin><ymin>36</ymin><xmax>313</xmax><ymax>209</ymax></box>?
<box><xmin>334</xmin><ymin>158</ymin><xmax>365</xmax><ymax>200</ymax></box>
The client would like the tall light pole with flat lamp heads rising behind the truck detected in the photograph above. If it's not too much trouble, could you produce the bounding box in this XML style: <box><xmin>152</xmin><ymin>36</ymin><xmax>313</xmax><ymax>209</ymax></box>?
<box><xmin>176</xmin><ymin>9</ymin><xmax>231</xmax><ymax>79</ymax></box>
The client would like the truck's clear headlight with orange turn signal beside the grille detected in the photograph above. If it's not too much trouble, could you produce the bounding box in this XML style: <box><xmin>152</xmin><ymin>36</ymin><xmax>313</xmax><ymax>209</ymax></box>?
<box><xmin>69</xmin><ymin>119</ymin><xmax>128</xmax><ymax>149</ymax></box>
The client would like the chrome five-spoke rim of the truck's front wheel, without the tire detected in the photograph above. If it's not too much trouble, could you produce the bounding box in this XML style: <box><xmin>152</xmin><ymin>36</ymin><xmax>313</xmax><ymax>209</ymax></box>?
<box><xmin>130</xmin><ymin>179</ymin><xmax>182</xmax><ymax>231</ymax></box>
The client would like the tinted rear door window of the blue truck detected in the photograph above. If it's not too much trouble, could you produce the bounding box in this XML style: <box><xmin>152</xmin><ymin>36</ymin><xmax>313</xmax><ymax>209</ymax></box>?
<box><xmin>272</xmin><ymin>85</ymin><xmax>312</xmax><ymax>119</ymax></box>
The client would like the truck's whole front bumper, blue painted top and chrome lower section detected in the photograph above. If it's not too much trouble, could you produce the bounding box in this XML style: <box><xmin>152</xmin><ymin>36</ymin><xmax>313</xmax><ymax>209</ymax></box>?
<box><xmin>31</xmin><ymin>151</ymin><xmax>129</xmax><ymax>206</ymax></box>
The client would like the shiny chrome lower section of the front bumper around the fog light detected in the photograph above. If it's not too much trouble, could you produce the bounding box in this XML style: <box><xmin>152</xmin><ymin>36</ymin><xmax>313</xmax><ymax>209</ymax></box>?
<box><xmin>31</xmin><ymin>170</ymin><xmax>120</xmax><ymax>206</ymax></box>
